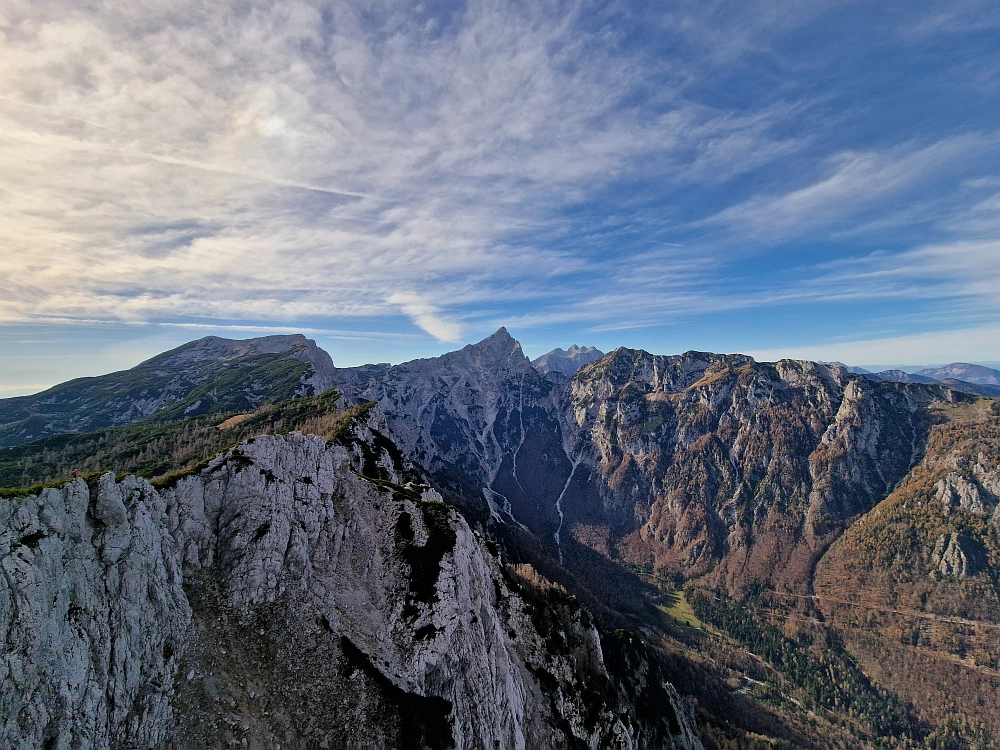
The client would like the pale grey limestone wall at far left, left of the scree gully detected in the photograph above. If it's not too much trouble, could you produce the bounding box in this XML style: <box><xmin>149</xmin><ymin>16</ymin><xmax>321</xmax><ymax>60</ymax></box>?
<box><xmin>0</xmin><ymin>474</ymin><xmax>191</xmax><ymax>750</ymax></box>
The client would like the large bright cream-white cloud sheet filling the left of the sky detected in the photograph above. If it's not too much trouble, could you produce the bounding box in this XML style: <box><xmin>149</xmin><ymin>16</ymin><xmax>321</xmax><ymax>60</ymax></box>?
<box><xmin>0</xmin><ymin>0</ymin><xmax>812</xmax><ymax>338</ymax></box>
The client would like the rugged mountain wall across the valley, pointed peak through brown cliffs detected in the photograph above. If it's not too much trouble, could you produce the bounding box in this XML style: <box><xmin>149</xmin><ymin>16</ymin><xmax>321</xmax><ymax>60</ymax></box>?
<box><xmin>338</xmin><ymin>329</ymin><xmax>961</xmax><ymax>590</ymax></box>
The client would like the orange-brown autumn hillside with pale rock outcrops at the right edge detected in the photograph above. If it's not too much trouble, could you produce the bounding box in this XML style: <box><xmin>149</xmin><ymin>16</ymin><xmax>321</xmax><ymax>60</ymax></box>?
<box><xmin>815</xmin><ymin>400</ymin><xmax>1000</xmax><ymax>747</ymax></box>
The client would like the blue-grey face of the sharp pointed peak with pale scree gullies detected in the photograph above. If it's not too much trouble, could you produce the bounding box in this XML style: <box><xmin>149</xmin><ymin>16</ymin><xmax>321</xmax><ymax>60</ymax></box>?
<box><xmin>337</xmin><ymin>328</ymin><xmax>562</xmax><ymax>528</ymax></box>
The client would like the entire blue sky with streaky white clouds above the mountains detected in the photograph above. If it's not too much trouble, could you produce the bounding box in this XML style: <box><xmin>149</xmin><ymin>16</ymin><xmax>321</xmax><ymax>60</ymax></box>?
<box><xmin>0</xmin><ymin>0</ymin><xmax>1000</xmax><ymax>396</ymax></box>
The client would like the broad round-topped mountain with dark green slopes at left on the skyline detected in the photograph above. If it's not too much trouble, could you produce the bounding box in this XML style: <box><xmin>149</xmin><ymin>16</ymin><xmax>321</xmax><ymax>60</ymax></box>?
<box><xmin>0</xmin><ymin>334</ymin><xmax>334</xmax><ymax>446</ymax></box>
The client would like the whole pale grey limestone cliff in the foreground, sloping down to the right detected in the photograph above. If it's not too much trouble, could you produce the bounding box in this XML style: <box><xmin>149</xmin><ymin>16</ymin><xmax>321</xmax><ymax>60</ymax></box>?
<box><xmin>0</xmin><ymin>412</ymin><xmax>700</xmax><ymax>748</ymax></box>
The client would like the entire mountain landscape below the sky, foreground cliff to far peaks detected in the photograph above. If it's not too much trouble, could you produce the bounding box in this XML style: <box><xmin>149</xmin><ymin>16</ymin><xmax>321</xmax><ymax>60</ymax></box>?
<box><xmin>0</xmin><ymin>329</ymin><xmax>1000</xmax><ymax>748</ymax></box>
